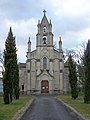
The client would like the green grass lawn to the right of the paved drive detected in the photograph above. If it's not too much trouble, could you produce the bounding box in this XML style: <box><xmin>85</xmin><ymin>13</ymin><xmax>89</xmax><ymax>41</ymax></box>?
<box><xmin>58</xmin><ymin>93</ymin><xmax>90</xmax><ymax>119</ymax></box>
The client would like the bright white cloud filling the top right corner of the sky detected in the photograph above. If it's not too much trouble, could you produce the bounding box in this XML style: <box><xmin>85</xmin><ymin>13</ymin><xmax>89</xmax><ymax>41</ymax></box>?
<box><xmin>51</xmin><ymin>0</ymin><xmax>90</xmax><ymax>17</ymax></box>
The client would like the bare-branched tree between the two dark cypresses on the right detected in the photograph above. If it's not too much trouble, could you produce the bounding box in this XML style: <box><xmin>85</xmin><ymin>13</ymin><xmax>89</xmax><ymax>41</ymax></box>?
<box><xmin>64</xmin><ymin>45</ymin><xmax>86</xmax><ymax>90</ymax></box>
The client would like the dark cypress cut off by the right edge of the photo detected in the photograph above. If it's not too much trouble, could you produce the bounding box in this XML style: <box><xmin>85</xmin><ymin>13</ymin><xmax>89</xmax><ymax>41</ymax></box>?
<box><xmin>84</xmin><ymin>40</ymin><xmax>90</xmax><ymax>103</ymax></box>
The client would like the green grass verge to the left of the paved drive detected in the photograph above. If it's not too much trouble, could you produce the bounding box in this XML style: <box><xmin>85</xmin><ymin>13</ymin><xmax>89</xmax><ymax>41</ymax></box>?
<box><xmin>0</xmin><ymin>95</ymin><xmax>32</xmax><ymax>120</ymax></box>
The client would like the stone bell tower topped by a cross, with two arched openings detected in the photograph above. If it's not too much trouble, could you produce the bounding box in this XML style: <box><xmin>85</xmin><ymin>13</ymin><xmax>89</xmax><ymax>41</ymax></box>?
<box><xmin>36</xmin><ymin>10</ymin><xmax>53</xmax><ymax>47</ymax></box>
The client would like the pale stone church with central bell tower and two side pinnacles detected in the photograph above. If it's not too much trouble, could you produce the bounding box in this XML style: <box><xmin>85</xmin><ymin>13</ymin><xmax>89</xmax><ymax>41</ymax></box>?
<box><xmin>19</xmin><ymin>10</ymin><xmax>70</xmax><ymax>94</ymax></box>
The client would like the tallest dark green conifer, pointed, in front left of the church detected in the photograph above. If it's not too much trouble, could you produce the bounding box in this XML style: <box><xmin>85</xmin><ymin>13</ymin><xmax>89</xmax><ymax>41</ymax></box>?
<box><xmin>3</xmin><ymin>27</ymin><xmax>19</xmax><ymax>104</ymax></box>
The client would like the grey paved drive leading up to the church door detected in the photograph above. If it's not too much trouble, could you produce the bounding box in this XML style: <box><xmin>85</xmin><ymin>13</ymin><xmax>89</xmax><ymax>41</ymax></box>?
<box><xmin>21</xmin><ymin>95</ymin><xmax>82</xmax><ymax>120</ymax></box>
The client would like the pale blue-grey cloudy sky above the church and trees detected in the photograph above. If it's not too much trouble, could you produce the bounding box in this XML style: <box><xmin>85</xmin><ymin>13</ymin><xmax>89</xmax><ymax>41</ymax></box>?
<box><xmin>0</xmin><ymin>0</ymin><xmax>90</xmax><ymax>62</ymax></box>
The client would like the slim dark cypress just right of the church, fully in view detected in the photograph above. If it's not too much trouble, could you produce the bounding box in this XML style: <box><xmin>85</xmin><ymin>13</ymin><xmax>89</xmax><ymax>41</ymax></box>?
<box><xmin>68</xmin><ymin>55</ymin><xmax>78</xmax><ymax>99</ymax></box>
